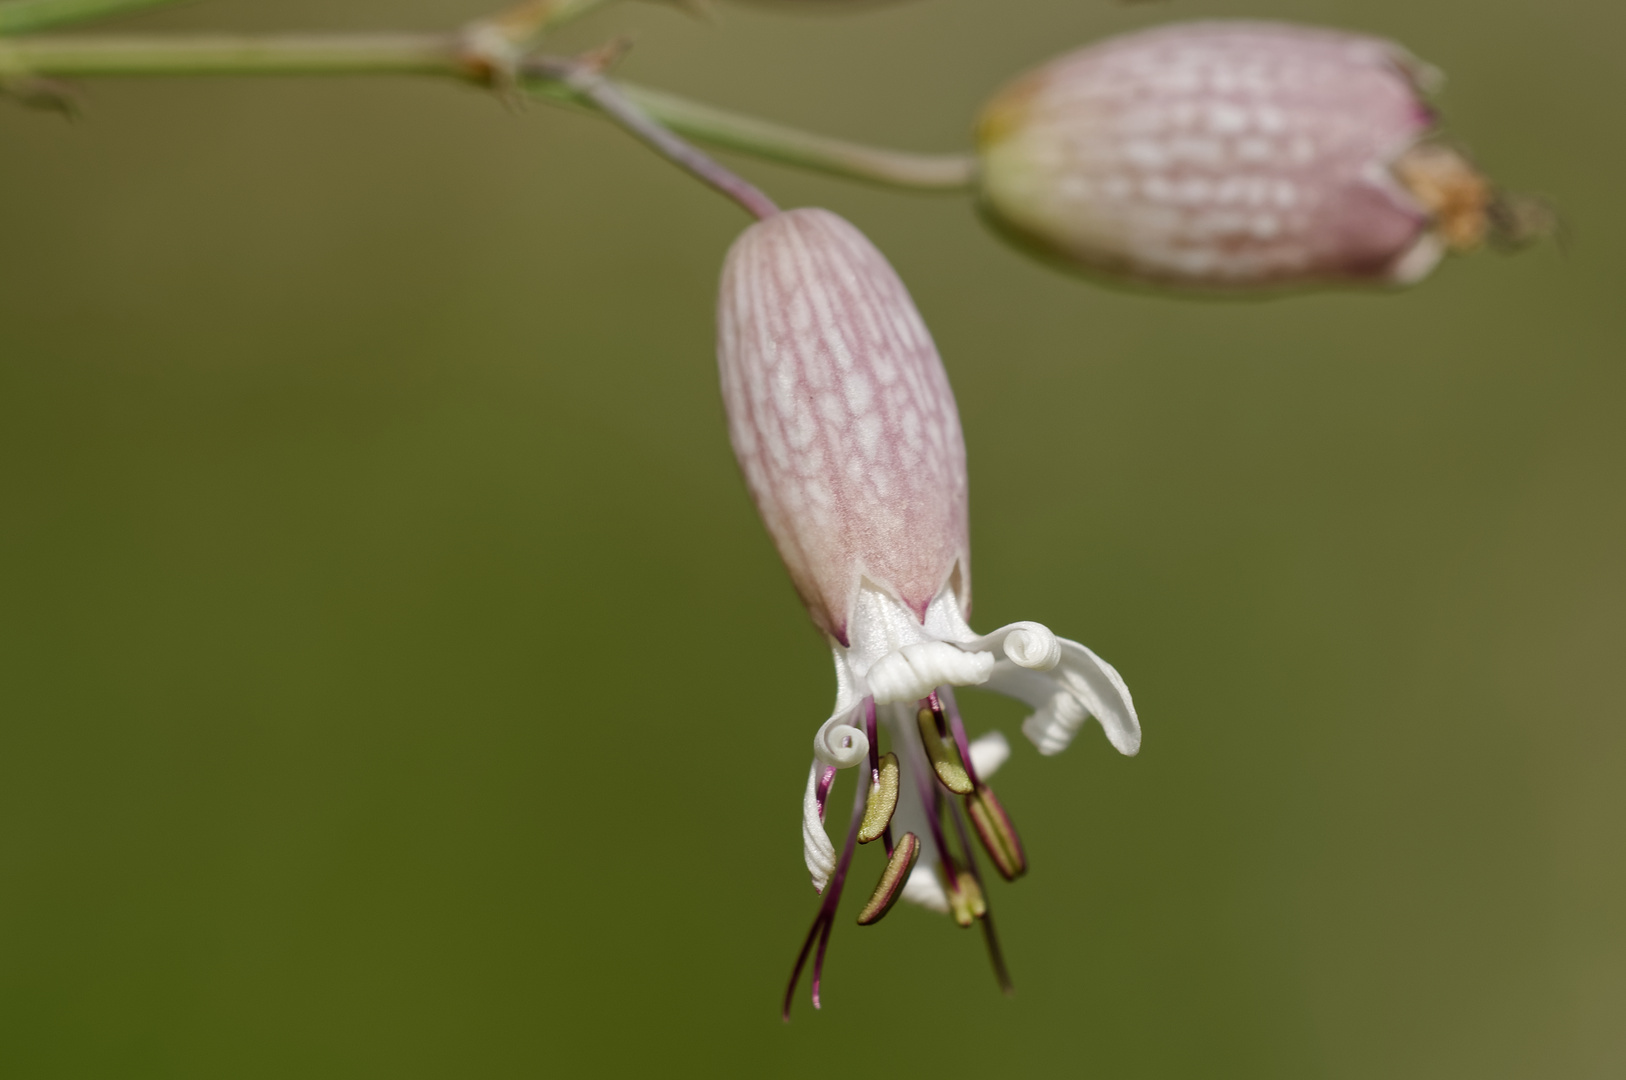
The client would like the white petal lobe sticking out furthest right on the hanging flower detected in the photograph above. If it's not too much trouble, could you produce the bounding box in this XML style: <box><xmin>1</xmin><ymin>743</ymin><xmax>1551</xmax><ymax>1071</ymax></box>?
<box><xmin>989</xmin><ymin>638</ymin><xmax>1140</xmax><ymax>755</ymax></box>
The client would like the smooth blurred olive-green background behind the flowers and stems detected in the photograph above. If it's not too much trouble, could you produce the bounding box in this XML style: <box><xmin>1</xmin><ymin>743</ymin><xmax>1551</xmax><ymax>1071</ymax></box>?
<box><xmin>0</xmin><ymin>0</ymin><xmax>1626</xmax><ymax>1078</ymax></box>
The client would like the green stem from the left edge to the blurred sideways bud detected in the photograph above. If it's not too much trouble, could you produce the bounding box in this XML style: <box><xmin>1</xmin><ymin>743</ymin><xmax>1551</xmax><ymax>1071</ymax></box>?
<box><xmin>0</xmin><ymin>34</ymin><xmax>976</xmax><ymax>192</ymax></box>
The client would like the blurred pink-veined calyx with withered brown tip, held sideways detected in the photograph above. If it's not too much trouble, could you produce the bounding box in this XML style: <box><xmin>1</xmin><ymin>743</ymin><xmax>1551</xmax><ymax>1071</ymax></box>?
<box><xmin>977</xmin><ymin>23</ymin><xmax>1532</xmax><ymax>290</ymax></box>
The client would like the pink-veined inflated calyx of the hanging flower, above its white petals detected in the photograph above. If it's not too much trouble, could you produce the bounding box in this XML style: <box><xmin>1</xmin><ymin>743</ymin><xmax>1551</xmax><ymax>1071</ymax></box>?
<box><xmin>717</xmin><ymin>210</ymin><xmax>971</xmax><ymax>646</ymax></box>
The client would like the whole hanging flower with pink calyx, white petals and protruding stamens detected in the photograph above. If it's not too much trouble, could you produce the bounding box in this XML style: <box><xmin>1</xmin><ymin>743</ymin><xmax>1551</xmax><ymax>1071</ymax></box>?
<box><xmin>717</xmin><ymin>210</ymin><xmax>1140</xmax><ymax>1015</ymax></box>
